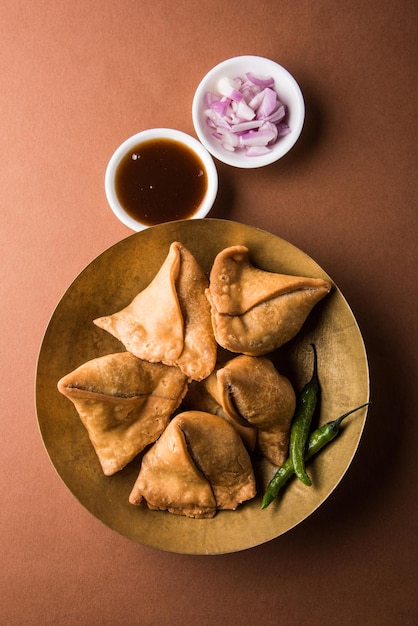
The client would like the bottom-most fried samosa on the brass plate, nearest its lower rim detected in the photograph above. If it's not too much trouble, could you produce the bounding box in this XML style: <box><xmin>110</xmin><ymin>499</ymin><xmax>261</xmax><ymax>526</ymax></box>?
<box><xmin>129</xmin><ymin>411</ymin><xmax>256</xmax><ymax>518</ymax></box>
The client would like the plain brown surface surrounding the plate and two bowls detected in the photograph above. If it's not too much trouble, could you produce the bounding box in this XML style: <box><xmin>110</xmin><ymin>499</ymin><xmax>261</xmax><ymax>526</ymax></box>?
<box><xmin>0</xmin><ymin>0</ymin><xmax>418</xmax><ymax>626</ymax></box>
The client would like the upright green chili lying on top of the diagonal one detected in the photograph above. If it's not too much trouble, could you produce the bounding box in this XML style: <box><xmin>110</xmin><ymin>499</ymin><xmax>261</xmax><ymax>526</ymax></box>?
<box><xmin>289</xmin><ymin>344</ymin><xmax>320</xmax><ymax>487</ymax></box>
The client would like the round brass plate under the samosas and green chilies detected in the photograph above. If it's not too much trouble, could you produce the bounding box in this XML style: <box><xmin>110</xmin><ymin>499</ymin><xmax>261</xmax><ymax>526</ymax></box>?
<box><xmin>36</xmin><ymin>219</ymin><xmax>369</xmax><ymax>554</ymax></box>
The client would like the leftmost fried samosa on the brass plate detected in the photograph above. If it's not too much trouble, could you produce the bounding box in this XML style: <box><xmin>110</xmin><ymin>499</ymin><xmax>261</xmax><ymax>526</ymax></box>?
<box><xmin>58</xmin><ymin>352</ymin><xmax>188</xmax><ymax>476</ymax></box>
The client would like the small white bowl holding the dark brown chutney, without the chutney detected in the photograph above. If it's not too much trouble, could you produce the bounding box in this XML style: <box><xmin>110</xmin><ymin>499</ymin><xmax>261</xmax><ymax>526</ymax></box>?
<box><xmin>105</xmin><ymin>128</ymin><xmax>218</xmax><ymax>231</ymax></box>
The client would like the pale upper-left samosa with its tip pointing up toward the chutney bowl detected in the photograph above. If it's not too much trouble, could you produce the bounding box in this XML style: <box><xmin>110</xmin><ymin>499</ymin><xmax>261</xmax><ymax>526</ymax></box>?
<box><xmin>94</xmin><ymin>242</ymin><xmax>217</xmax><ymax>380</ymax></box>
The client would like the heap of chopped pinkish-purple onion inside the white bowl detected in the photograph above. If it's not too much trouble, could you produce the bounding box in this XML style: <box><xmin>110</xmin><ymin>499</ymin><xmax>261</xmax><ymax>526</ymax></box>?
<box><xmin>204</xmin><ymin>72</ymin><xmax>291</xmax><ymax>157</ymax></box>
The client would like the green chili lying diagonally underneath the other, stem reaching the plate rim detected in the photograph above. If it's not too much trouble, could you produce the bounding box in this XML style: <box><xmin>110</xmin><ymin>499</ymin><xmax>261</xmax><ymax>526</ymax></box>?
<box><xmin>261</xmin><ymin>402</ymin><xmax>370</xmax><ymax>509</ymax></box>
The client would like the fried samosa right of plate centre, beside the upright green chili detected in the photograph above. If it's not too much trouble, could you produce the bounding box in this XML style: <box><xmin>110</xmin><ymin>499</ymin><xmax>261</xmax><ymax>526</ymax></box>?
<box><xmin>184</xmin><ymin>355</ymin><xmax>296</xmax><ymax>466</ymax></box>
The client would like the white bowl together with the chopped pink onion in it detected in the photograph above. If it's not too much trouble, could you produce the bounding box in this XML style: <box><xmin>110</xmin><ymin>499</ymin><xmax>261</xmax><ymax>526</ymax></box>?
<box><xmin>192</xmin><ymin>55</ymin><xmax>305</xmax><ymax>168</ymax></box>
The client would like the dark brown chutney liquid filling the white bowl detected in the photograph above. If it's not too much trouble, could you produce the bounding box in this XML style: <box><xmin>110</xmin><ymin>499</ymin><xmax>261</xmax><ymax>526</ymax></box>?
<box><xmin>115</xmin><ymin>138</ymin><xmax>208</xmax><ymax>226</ymax></box>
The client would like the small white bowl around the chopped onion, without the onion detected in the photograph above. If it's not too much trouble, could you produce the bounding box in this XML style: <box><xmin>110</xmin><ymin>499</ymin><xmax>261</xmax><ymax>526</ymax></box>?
<box><xmin>192</xmin><ymin>55</ymin><xmax>305</xmax><ymax>168</ymax></box>
